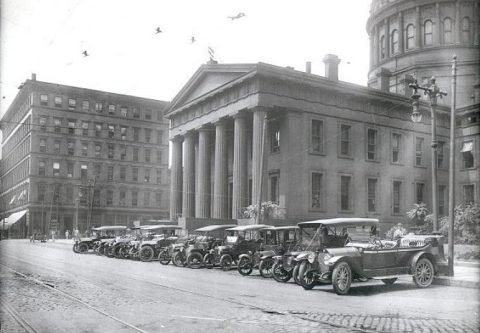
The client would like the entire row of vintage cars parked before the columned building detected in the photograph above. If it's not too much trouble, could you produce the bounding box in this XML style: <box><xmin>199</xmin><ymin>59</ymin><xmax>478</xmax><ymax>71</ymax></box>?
<box><xmin>73</xmin><ymin>218</ymin><xmax>447</xmax><ymax>295</ymax></box>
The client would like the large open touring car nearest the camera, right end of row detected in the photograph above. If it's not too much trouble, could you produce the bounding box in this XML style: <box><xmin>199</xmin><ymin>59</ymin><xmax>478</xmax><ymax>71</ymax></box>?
<box><xmin>299</xmin><ymin>218</ymin><xmax>446</xmax><ymax>295</ymax></box>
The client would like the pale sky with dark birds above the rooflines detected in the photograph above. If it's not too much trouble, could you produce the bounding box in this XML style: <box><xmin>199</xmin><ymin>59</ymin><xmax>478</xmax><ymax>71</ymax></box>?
<box><xmin>0</xmin><ymin>0</ymin><xmax>371</xmax><ymax>115</ymax></box>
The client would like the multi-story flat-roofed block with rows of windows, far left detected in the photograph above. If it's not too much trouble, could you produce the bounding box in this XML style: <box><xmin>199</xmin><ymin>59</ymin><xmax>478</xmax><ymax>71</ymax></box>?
<box><xmin>0</xmin><ymin>75</ymin><xmax>169</xmax><ymax>234</ymax></box>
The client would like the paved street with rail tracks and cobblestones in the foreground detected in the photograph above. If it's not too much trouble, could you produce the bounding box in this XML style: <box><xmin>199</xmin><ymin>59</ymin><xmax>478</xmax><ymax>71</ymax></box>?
<box><xmin>0</xmin><ymin>240</ymin><xmax>479</xmax><ymax>332</ymax></box>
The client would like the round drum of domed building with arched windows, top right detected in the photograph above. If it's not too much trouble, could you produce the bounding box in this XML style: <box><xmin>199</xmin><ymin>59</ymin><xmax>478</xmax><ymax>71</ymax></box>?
<box><xmin>367</xmin><ymin>0</ymin><xmax>480</xmax><ymax>107</ymax></box>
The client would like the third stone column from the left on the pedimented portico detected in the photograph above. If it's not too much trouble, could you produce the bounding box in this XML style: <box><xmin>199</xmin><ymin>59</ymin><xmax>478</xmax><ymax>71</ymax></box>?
<box><xmin>195</xmin><ymin>127</ymin><xmax>211</xmax><ymax>218</ymax></box>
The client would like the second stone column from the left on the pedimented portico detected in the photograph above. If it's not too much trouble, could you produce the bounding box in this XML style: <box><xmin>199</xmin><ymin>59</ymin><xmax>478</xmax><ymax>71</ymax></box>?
<box><xmin>182</xmin><ymin>132</ymin><xmax>195</xmax><ymax>217</ymax></box>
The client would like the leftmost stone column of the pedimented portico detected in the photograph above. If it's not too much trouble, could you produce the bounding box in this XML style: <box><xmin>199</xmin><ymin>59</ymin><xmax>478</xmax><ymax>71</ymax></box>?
<box><xmin>170</xmin><ymin>136</ymin><xmax>183</xmax><ymax>221</ymax></box>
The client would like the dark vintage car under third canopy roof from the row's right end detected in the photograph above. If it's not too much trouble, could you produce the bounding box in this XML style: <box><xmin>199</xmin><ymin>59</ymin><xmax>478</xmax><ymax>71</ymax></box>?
<box><xmin>203</xmin><ymin>224</ymin><xmax>272</xmax><ymax>271</ymax></box>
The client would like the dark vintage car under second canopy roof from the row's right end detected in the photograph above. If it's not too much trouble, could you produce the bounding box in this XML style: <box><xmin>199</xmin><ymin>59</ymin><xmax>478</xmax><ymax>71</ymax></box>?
<box><xmin>237</xmin><ymin>226</ymin><xmax>298</xmax><ymax>278</ymax></box>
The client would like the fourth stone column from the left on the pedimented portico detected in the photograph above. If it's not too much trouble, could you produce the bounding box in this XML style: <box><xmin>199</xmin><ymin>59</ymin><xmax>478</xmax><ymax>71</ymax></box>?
<box><xmin>213</xmin><ymin>120</ymin><xmax>228</xmax><ymax>219</ymax></box>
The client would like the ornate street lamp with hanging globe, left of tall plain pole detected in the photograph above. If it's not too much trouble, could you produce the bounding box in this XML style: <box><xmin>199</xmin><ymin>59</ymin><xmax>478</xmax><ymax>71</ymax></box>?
<box><xmin>408</xmin><ymin>77</ymin><xmax>447</xmax><ymax>231</ymax></box>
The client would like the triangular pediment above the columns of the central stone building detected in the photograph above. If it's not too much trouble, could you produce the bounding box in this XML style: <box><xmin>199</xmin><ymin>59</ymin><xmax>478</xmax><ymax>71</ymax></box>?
<box><xmin>167</xmin><ymin>64</ymin><xmax>255</xmax><ymax>114</ymax></box>
